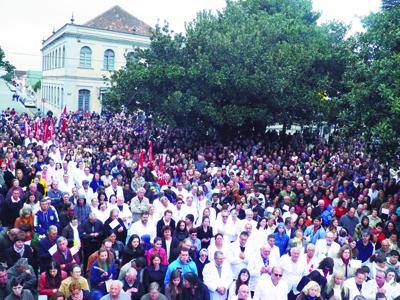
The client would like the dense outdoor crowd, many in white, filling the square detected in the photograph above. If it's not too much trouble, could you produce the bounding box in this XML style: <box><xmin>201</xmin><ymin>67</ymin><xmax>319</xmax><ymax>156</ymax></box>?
<box><xmin>0</xmin><ymin>110</ymin><xmax>400</xmax><ymax>300</ymax></box>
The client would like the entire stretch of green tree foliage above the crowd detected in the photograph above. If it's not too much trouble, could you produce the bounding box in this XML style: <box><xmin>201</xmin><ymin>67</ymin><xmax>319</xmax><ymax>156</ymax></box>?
<box><xmin>103</xmin><ymin>0</ymin><xmax>400</xmax><ymax>159</ymax></box>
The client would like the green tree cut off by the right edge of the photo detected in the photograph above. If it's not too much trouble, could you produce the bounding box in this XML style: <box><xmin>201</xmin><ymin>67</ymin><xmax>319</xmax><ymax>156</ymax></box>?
<box><xmin>339</xmin><ymin>0</ymin><xmax>400</xmax><ymax>160</ymax></box>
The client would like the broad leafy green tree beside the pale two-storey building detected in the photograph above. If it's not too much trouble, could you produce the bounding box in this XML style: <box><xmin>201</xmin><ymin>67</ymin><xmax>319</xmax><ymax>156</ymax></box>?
<box><xmin>103</xmin><ymin>0</ymin><xmax>346</xmax><ymax>134</ymax></box>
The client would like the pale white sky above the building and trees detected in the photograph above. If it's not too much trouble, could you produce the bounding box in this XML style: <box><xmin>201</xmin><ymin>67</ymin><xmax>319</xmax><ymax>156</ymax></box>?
<box><xmin>0</xmin><ymin>0</ymin><xmax>381</xmax><ymax>70</ymax></box>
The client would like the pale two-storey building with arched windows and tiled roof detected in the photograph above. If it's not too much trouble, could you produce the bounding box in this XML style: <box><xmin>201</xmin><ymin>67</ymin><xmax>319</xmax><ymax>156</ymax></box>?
<box><xmin>41</xmin><ymin>6</ymin><xmax>151</xmax><ymax>113</ymax></box>
